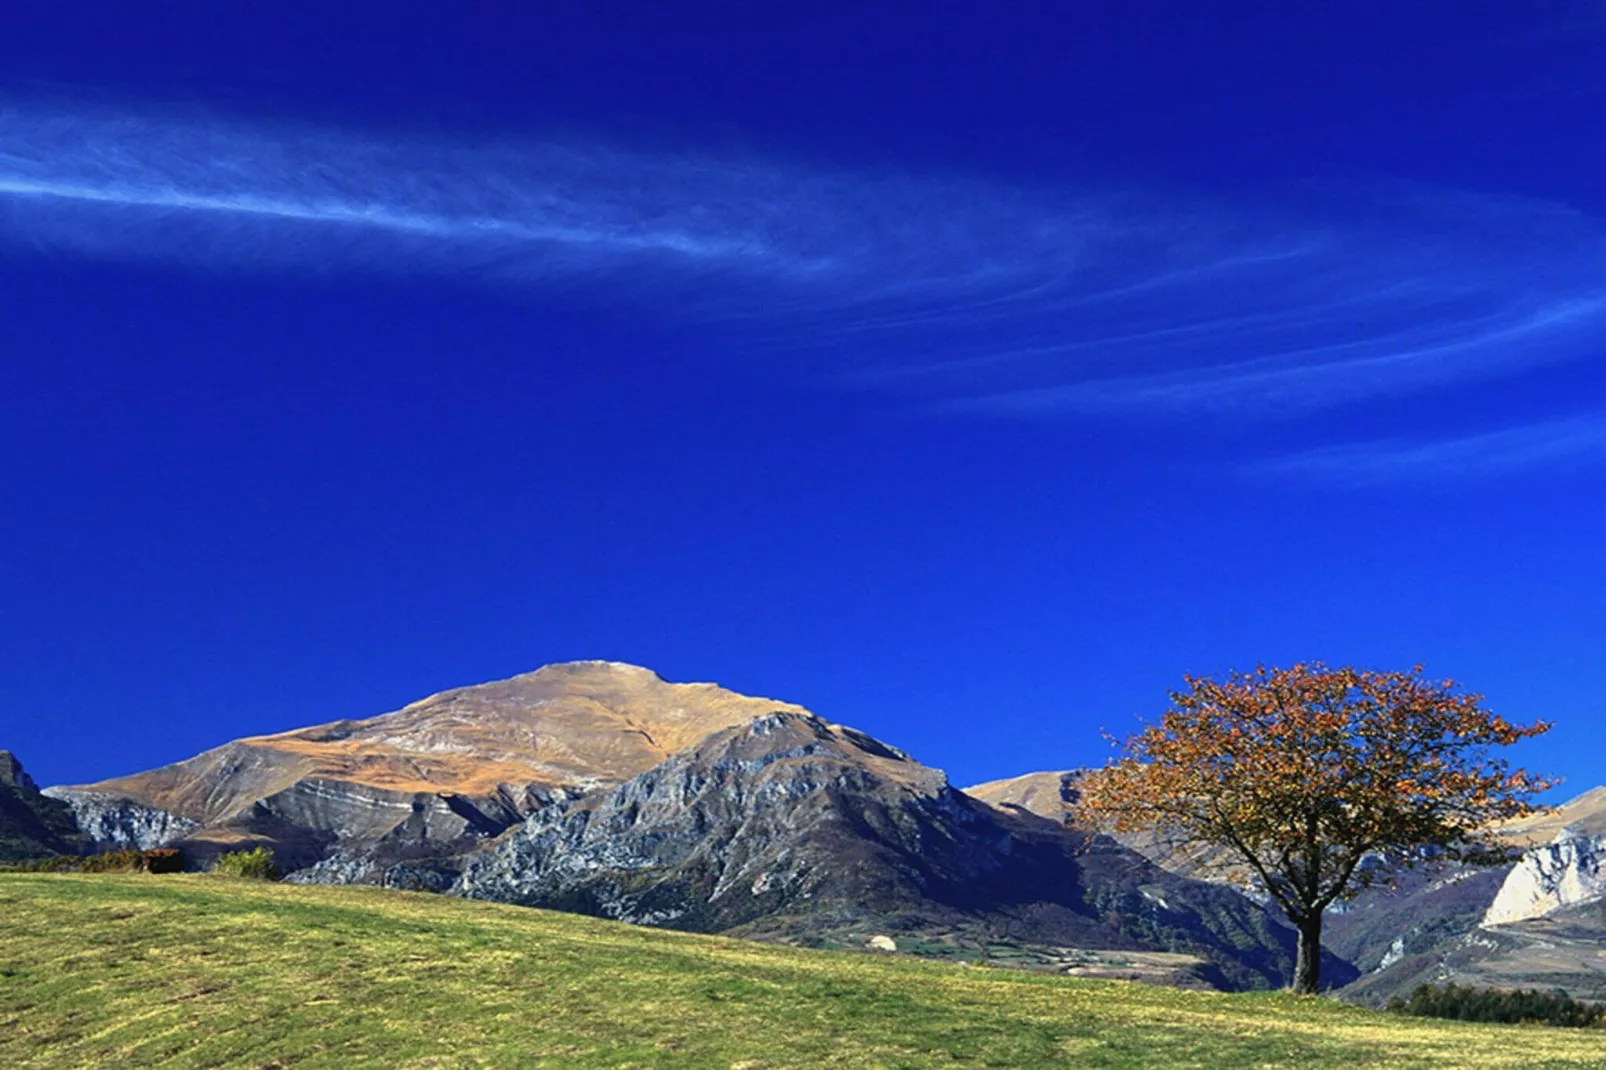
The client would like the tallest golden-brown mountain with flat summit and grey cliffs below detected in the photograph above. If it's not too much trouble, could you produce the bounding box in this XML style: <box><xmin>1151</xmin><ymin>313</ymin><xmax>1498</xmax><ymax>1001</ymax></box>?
<box><xmin>51</xmin><ymin>660</ymin><xmax>809</xmax><ymax>866</ymax></box>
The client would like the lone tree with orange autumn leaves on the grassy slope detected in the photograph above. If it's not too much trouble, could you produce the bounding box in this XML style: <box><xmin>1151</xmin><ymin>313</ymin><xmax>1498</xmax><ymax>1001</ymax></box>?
<box><xmin>1078</xmin><ymin>662</ymin><xmax>1553</xmax><ymax>993</ymax></box>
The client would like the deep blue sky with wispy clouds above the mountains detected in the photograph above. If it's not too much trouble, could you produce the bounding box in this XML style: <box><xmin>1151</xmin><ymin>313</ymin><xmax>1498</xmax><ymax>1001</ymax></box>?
<box><xmin>0</xmin><ymin>3</ymin><xmax>1606</xmax><ymax>794</ymax></box>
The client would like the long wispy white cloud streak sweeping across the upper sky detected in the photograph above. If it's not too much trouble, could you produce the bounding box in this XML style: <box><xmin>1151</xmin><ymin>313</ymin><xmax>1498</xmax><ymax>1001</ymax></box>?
<box><xmin>9</xmin><ymin>103</ymin><xmax>1606</xmax><ymax>418</ymax></box>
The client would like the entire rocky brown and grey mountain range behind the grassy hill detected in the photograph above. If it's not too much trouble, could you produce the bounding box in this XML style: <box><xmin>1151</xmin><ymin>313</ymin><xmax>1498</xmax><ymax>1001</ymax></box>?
<box><xmin>15</xmin><ymin>662</ymin><xmax>1606</xmax><ymax>999</ymax></box>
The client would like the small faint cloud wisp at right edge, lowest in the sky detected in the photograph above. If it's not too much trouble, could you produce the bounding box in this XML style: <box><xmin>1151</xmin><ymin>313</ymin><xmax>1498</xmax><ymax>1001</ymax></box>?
<box><xmin>1249</xmin><ymin>415</ymin><xmax>1606</xmax><ymax>487</ymax></box>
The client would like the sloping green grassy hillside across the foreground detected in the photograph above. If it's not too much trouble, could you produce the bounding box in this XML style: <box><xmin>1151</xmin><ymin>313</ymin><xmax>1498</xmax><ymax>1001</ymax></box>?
<box><xmin>0</xmin><ymin>874</ymin><xmax>1606</xmax><ymax>1070</ymax></box>
